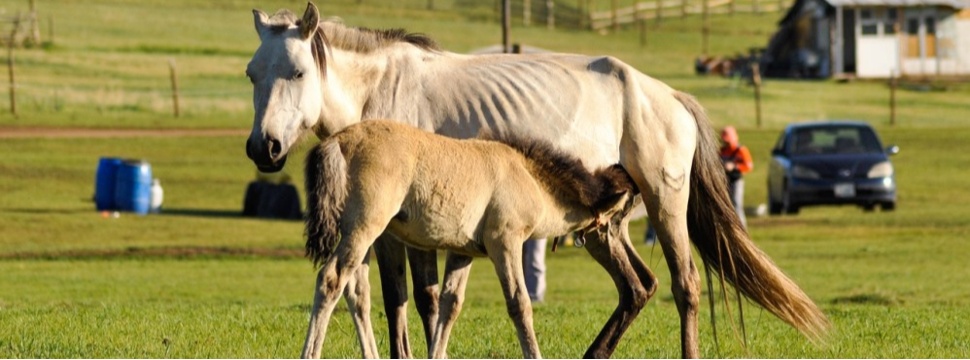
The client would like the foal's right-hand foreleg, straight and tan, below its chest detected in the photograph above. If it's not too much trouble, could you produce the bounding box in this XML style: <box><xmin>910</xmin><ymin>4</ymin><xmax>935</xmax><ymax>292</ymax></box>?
<box><xmin>485</xmin><ymin>239</ymin><xmax>542</xmax><ymax>359</ymax></box>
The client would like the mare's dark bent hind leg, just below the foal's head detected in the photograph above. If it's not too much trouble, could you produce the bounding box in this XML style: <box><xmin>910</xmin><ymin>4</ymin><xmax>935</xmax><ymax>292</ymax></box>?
<box><xmin>583</xmin><ymin>204</ymin><xmax>657</xmax><ymax>358</ymax></box>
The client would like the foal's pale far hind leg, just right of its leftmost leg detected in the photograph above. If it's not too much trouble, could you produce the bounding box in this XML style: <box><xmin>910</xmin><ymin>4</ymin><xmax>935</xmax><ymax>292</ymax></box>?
<box><xmin>344</xmin><ymin>248</ymin><xmax>380</xmax><ymax>359</ymax></box>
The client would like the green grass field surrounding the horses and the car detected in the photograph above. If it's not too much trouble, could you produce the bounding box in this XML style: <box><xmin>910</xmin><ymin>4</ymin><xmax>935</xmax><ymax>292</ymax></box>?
<box><xmin>0</xmin><ymin>0</ymin><xmax>970</xmax><ymax>358</ymax></box>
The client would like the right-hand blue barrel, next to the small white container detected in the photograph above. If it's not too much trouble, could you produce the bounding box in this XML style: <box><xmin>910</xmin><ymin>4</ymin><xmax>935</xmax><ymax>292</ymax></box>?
<box><xmin>115</xmin><ymin>160</ymin><xmax>152</xmax><ymax>215</ymax></box>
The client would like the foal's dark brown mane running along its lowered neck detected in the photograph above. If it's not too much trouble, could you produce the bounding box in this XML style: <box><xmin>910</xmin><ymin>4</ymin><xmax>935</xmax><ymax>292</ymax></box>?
<box><xmin>479</xmin><ymin>133</ymin><xmax>638</xmax><ymax>211</ymax></box>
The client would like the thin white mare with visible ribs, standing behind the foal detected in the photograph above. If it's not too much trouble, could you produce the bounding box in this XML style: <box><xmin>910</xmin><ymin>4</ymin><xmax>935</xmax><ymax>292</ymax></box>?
<box><xmin>246</xmin><ymin>3</ymin><xmax>828</xmax><ymax>357</ymax></box>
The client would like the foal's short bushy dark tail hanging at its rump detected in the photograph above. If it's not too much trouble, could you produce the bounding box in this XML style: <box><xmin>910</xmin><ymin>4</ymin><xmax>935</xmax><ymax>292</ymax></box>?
<box><xmin>305</xmin><ymin>139</ymin><xmax>347</xmax><ymax>266</ymax></box>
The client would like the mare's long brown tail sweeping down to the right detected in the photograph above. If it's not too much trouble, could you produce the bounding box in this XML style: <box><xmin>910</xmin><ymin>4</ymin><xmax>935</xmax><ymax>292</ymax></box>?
<box><xmin>674</xmin><ymin>92</ymin><xmax>829</xmax><ymax>341</ymax></box>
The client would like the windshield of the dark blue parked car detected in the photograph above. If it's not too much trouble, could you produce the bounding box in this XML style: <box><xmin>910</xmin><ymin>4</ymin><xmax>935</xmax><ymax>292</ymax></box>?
<box><xmin>791</xmin><ymin>126</ymin><xmax>882</xmax><ymax>155</ymax></box>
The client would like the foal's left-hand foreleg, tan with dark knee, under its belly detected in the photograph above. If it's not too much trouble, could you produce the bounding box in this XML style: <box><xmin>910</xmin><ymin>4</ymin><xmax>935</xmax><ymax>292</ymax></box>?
<box><xmin>429</xmin><ymin>251</ymin><xmax>472</xmax><ymax>359</ymax></box>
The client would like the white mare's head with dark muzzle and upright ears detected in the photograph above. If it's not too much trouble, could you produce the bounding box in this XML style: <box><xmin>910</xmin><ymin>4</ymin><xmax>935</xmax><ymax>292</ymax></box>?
<box><xmin>246</xmin><ymin>3</ymin><xmax>326</xmax><ymax>172</ymax></box>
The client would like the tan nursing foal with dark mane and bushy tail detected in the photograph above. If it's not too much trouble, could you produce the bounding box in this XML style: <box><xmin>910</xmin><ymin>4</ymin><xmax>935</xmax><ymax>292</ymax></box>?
<box><xmin>303</xmin><ymin>120</ymin><xmax>637</xmax><ymax>358</ymax></box>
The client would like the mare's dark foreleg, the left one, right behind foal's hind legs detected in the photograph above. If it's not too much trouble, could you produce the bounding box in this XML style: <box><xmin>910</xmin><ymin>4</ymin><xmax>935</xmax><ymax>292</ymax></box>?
<box><xmin>374</xmin><ymin>232</ymin><xmax>414</xmax><ymax>359</ymax></box>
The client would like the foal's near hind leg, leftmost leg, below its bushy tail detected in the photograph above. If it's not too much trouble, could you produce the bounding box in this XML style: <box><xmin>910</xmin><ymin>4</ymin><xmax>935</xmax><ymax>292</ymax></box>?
<box><xmin>301</xmin><ymin>230</ymin><xmax>379</xmax><ymax>359</ymax></box>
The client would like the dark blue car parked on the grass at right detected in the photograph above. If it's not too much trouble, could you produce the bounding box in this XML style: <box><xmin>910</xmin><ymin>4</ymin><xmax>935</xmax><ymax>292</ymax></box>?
<box><xmin>768</xmin><ymin>121</ymin><xmax>899</xmax><ymax>215</ymax></box>
